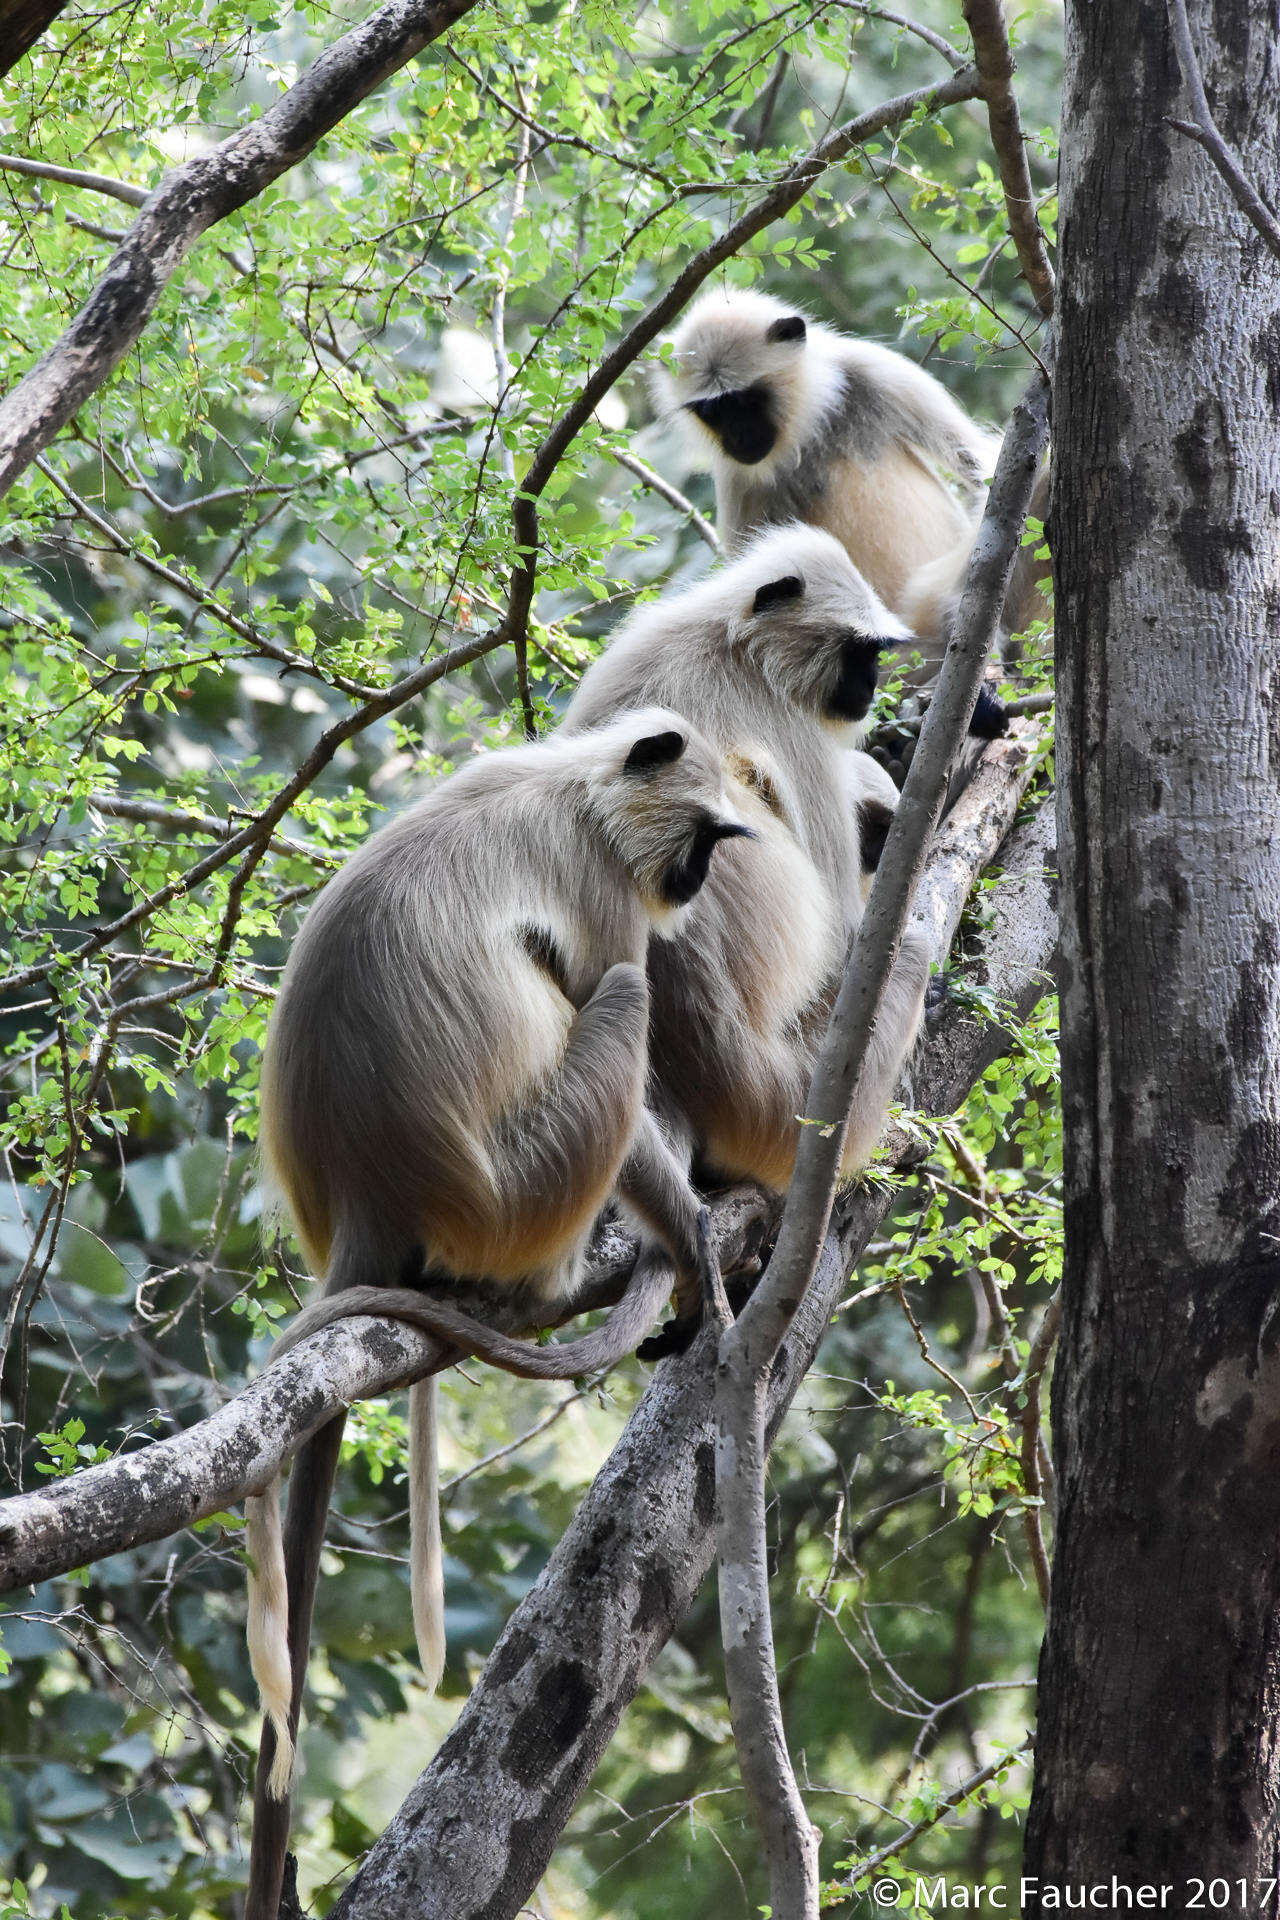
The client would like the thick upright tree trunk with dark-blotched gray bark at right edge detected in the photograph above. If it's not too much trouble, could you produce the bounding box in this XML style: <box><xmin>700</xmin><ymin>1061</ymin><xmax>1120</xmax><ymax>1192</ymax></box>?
<box><xmin>1027</xmin><ymin>0</ymin><xmax>1280</xmax><ymax>1889</ymax></box>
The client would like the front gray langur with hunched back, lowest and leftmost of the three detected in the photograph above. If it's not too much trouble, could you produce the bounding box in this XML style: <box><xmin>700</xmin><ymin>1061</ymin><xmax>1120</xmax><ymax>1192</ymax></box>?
<box><xmin>239</xmin><ymin>718</ymin><xmax>748</xmax><ymax>1914</ymax></box>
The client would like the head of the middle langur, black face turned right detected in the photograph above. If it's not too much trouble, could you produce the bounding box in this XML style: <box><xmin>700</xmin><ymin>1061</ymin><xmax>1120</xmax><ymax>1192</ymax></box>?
<box><xmin>723</xmin><ymin>520</ymin><xmax>913</xmax><ymax>745</ymax></box>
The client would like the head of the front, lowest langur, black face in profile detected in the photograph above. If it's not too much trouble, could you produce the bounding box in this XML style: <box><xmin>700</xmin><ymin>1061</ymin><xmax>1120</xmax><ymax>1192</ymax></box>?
<box><xmin>574</xmin><ymin>707</ymin><xmax>752</xmax><ymax>931</ymax></box>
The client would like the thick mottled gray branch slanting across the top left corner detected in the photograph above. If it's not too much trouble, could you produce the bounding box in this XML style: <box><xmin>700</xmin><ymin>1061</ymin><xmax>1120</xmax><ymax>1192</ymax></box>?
<box><xmin>0</xmin><ymin>0</ymin><xmax>476</xmax><ymax>495</ymax></box>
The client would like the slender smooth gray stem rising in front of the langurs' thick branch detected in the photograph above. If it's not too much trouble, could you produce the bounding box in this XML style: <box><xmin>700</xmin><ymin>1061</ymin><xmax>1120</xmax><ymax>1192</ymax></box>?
<box><xmin>716</xmin><ymin>374</ymin><xmax>1048</xmax><ymax>1920</ymax></box>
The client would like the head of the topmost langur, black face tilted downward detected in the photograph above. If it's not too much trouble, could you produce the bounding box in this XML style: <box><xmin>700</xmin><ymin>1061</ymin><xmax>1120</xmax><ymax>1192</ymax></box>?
<box><xmin>654</xmin><ymin>290</ymin><xmax>841</xmax><ymax>480</ymax></box>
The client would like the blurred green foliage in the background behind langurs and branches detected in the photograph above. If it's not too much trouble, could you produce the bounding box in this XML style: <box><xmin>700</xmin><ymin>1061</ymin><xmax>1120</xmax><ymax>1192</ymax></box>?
<box><xmin>0</xmin><ymin>0</ymin><xmax>1059</xmax><ymax>1920</ymax></box>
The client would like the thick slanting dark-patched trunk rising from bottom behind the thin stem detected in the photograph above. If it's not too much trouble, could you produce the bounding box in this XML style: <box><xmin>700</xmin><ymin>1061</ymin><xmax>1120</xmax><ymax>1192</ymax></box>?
<box><xmin>334</xmin><ymin>756</ymin><xmax>1055</xmax><ymax>1920</ymax></box>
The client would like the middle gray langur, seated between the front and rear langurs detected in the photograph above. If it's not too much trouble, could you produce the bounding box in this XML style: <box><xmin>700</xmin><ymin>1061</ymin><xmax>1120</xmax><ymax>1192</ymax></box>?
<box><xmin>564</xmin><ymin>524</ymin><xmax>929</xmax><ymax>1244</ymax></box>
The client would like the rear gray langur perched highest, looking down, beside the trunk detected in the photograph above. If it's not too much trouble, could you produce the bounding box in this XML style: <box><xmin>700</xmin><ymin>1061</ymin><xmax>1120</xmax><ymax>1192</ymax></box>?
<box><xmin>654</xmin><ymin>290</ymin><xmax>1034</xmax><ymax>739</ymax></box>
